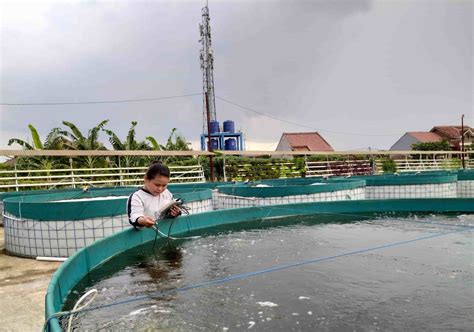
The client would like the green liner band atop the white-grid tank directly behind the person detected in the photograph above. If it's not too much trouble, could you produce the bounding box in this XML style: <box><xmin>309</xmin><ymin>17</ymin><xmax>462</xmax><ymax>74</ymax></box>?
<box><xmin>3</xmin><ymin>187</ymin><xmax>212</xmax><ymax>221</ymax></box>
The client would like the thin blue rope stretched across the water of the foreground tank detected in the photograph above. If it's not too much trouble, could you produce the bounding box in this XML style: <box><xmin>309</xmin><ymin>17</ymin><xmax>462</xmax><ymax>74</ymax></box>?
<box><xmin>44</xmin><ymin>223</ymin><xmax>474</xmax><ymax>328</ymax></box>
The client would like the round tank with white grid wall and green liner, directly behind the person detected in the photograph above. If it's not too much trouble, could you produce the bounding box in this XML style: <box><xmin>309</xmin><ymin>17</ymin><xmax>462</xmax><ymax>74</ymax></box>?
<box><xmin>3</xmin><ymin>187</ymin><xmax>212</xmax><ymax>258</ymax></box>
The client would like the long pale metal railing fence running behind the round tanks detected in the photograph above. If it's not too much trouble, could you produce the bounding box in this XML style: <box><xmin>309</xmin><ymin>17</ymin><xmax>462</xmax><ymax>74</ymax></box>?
<box><xmin>0</xmin><ymin>150</ymin><xmax>474</xmax><ymax>191</ymax></box>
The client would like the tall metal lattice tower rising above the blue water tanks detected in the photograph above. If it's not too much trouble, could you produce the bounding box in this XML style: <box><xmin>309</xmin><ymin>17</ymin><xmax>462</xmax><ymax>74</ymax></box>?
<box><xmin>199</xmin><ymin>5</ymin><xmax>217</xmax><ymax>133</ymax></box>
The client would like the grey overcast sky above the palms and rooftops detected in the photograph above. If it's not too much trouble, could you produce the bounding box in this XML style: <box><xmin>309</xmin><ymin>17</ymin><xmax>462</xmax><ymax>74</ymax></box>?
<box><xmin>0</xmin><ymin>0</ymin><xmax>474</xmax><ymax>150</ymax></box>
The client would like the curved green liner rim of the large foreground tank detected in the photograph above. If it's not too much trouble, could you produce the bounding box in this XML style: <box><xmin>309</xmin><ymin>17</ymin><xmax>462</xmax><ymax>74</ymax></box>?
<box><xmin>45</xmin><ymin>198</ymin><xmax>474</xmax><ymax>331</ymax></box>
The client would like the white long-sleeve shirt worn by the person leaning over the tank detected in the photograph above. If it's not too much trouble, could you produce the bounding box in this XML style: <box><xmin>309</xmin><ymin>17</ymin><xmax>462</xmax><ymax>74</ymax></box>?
<box><xmin>127</xmin><ymin>188</ymin><xmax>173</xmax><ymax>228</ymax></box>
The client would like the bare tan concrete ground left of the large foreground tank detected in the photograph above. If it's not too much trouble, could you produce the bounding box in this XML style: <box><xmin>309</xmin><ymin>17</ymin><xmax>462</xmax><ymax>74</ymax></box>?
<box><xmin>0</xmin><ymin>227</ymin><xmax>61</xmax><ymax>331</ymax></box>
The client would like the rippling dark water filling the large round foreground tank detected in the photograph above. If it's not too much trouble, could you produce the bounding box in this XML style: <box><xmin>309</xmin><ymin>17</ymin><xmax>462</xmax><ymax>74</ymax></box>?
<box><xmin>57</xmin><ymin>204</ymin><xmax>474</xmax><ymax>331</ymax></box>
